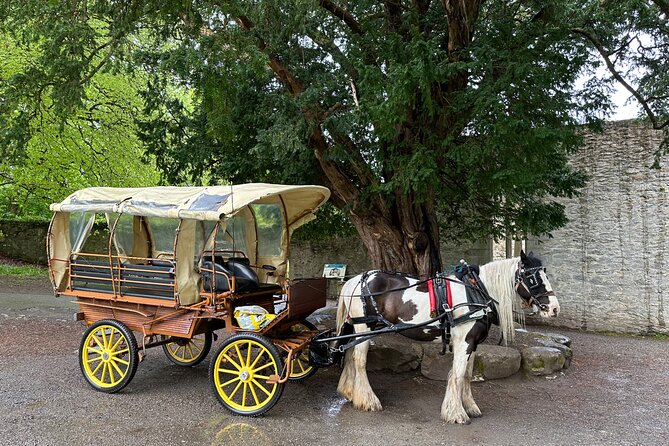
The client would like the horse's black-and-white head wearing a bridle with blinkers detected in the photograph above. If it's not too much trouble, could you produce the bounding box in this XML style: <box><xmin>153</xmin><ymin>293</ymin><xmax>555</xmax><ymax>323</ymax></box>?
<box><xmin>516</xmin><ymin>251</ymin><xmax>560</xmax><ymax>318</ymax></box>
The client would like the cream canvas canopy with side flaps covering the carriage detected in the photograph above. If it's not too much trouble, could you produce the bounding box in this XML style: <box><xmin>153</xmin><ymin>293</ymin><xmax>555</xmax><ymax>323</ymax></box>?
<box><xmin>48</xmin><ymin>183</ymin><xmax>330</xmax><ymax>304</ymax></box>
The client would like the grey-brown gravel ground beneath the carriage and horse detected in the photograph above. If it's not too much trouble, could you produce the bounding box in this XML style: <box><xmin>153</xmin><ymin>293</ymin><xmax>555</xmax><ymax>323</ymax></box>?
<box><xmin>0</xmin><ymin>277</ymin><xmax>669</xmax><ymax>446</ymax></box>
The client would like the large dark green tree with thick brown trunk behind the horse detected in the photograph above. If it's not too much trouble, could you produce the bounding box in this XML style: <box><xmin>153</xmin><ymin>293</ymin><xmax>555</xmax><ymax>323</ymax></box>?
<box><xmin>0</xmin><ymin>0</ymin><xmax>664</xmax><ymax>274</ymax></box>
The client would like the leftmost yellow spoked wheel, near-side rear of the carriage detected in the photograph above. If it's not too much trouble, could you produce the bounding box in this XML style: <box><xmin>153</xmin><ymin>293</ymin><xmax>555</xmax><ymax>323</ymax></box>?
<box><xmin>79</xmin><ymin>319</ymin><xmax>139</xmax><ymax>393</ymax></box>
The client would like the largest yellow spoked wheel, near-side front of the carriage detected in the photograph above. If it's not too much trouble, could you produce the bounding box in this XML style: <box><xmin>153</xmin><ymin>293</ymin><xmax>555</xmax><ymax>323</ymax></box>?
<box><xmin>209</xmin><ymin>333</ymin><xmax>283</xmax><ymax>416</ymax></box>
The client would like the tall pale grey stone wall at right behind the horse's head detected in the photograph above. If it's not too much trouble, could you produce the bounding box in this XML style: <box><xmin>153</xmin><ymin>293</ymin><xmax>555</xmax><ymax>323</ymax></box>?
<box><xmin>528</xmin><ymin>121</ymin><xmax>669</xmax><ymax>333</ymax></box>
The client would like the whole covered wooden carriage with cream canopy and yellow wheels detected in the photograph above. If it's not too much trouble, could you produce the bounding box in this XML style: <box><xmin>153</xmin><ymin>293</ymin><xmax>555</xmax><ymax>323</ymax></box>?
<box><xmin>47</xmin><ymin>184</ymin><xmax>330</xmax><ymax>416</ymax></box>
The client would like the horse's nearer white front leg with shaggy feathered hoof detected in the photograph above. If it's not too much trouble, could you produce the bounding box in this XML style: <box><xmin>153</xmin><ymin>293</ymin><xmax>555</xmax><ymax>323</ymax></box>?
<box><xmin>441</xmin><ymin>322</ymin><xmax>474</xmax><ymax>424</ymax></box>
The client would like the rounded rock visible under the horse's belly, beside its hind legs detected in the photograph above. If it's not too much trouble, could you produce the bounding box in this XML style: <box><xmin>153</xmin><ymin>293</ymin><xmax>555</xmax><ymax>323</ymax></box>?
<box><xmin>367</xmin><ymin>334</ymin><xmax>423</xmax><ymax>372</ymax></box>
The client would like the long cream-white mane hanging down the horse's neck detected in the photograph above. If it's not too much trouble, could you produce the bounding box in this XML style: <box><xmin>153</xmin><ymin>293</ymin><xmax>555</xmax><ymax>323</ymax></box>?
<box><xmin>479</xmin><ymin>257</ymin><xmax>525</xmax><ymax>343</ymax></box>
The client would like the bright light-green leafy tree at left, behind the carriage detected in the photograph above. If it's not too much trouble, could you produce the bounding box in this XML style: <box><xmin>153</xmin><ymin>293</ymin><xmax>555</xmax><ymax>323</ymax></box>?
<box><xmin>0</xmin><ymin>31</ymin><xmax>159</xmax><ymax>218</ymax></box>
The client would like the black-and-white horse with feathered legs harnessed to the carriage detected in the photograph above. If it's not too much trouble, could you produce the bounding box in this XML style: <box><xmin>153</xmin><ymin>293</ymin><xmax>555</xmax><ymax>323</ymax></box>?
<box><xmin>336</xmin><ymin>251</ymin><xmax>560</xmax><ymax>424</ymax></box>
